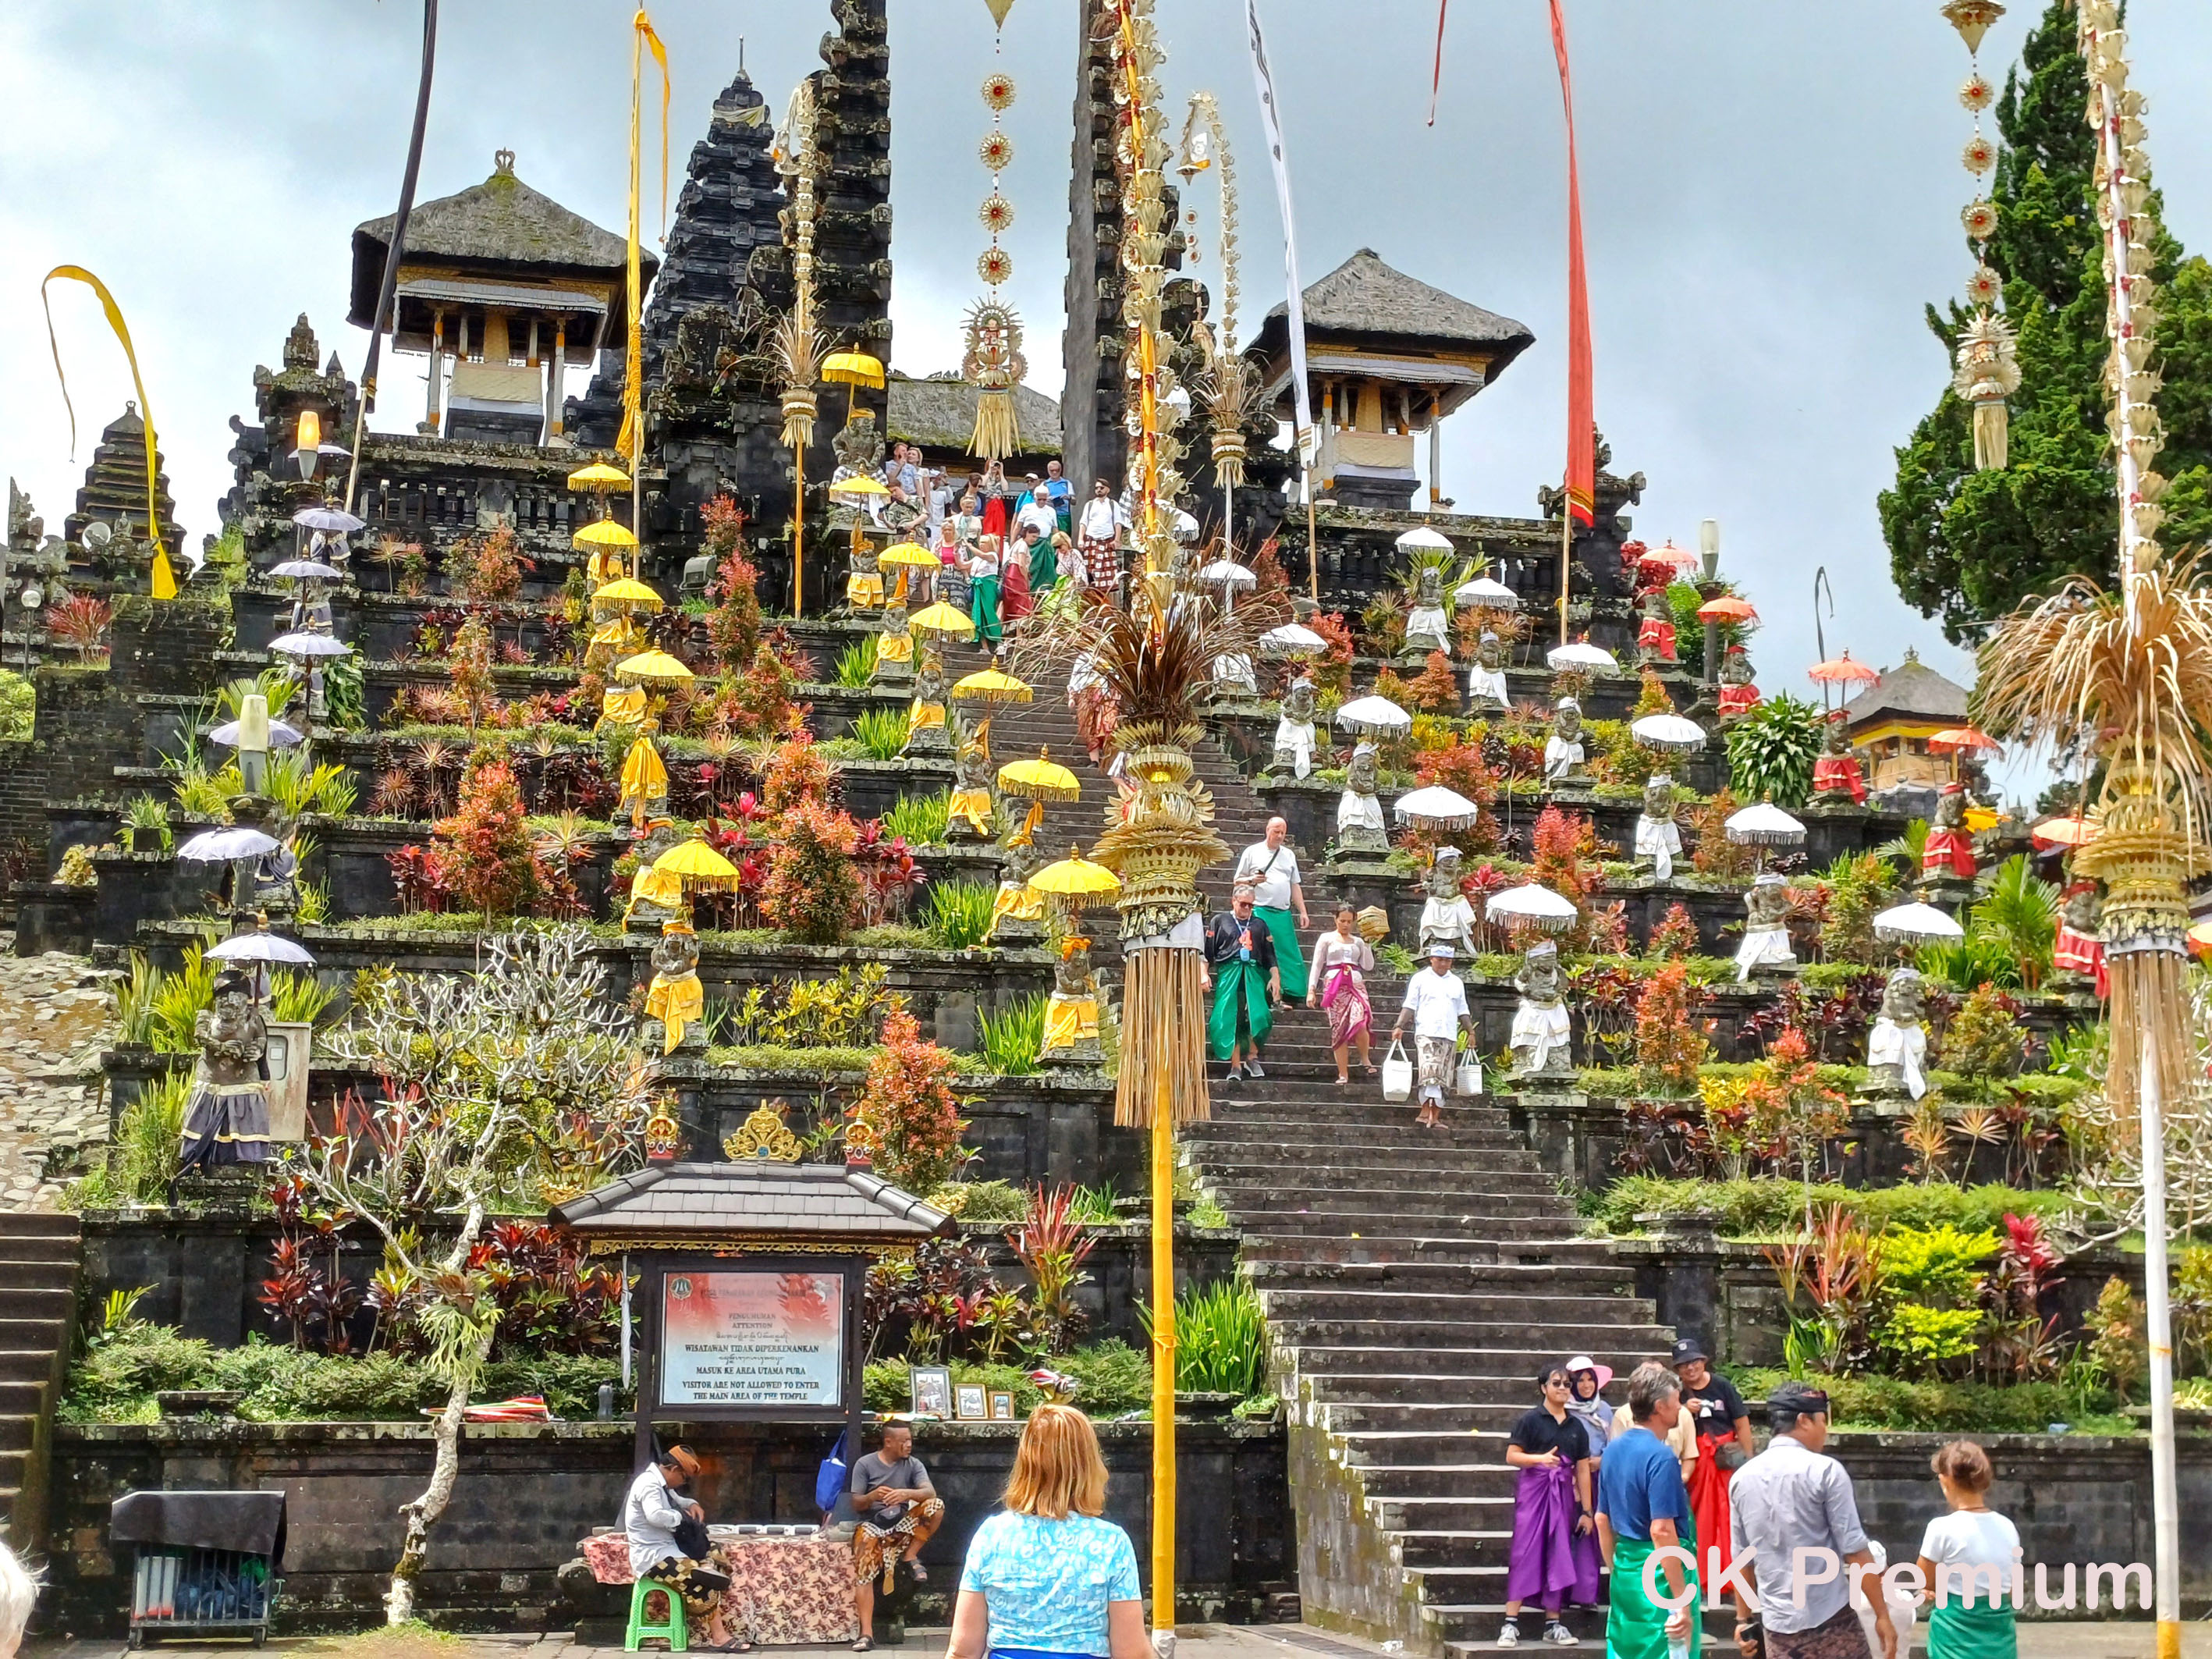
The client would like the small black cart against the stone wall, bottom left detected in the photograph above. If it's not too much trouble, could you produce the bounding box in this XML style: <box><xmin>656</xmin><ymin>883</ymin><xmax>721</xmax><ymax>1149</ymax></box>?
<box><xmin>108</xmin><ymin>1491</ymin><xmax>286</xmax><ymax>1648</ymax></box>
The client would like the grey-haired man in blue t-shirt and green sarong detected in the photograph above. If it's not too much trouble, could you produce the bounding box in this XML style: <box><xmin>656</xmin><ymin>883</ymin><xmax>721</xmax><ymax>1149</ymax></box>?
<box><xmin>1597</xmin><ymin>1360</ymin><xmax>1699</xmax><ymax>1659</ymax></box>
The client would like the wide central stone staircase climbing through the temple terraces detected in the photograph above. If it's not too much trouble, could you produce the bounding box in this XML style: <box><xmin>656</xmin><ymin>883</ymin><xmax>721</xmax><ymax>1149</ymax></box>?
<box><xmin>925</xmin><ymin>632</ymin><xmax>1672</xmax><ymax>1654</ymax></box>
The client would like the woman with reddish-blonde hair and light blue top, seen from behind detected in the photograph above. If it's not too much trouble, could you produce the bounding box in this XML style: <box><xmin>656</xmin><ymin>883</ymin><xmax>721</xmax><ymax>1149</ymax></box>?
<box><xmin>945</xmin><ymin>1405</ymin><xmax>1152</xmax><ymax>1659</ymax></box>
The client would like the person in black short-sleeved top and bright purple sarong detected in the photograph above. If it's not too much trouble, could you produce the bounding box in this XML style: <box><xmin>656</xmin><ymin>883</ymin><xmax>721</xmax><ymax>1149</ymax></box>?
<box><xmin>1497</xmin><ymin>1365</ymin><xmax>1600</xmax><ymax>1648</ymax></box>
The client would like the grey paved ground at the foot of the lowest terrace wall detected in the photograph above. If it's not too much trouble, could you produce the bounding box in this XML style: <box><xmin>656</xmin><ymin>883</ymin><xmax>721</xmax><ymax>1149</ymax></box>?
<box><xmin>24</xmin><ymin>1622</ymin><xmax>2212</xmax><ymax>1659</ymax></box>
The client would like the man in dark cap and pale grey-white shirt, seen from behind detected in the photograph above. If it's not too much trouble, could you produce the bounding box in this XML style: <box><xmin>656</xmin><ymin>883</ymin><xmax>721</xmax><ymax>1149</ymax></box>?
<box><xmin>1727</xmin><ymin>1383</ymin><xmax>1898</xmax><ymax>1659</ymax></box>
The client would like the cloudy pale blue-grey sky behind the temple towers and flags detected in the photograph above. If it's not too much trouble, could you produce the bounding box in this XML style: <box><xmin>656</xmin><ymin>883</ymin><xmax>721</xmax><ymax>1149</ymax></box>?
<box><xmin>0</xmin><ymin>0</ymin><xmax>2212</xmax><ymax>791</ymax></box>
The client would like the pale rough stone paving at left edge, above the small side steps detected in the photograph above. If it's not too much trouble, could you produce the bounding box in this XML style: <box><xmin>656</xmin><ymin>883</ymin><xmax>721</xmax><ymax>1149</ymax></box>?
<box><xmin>0</xmin><ymin>933</ymin><xmax>115</xmax><ymax>1210</ymax></box>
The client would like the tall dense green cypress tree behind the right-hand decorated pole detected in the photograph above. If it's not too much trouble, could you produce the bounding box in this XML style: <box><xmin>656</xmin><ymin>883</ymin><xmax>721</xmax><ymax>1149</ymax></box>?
<box><xmin>1878</xmin><ymin>0</ymin><xmax>2212</xmax><ymax>644</ymax></box>
